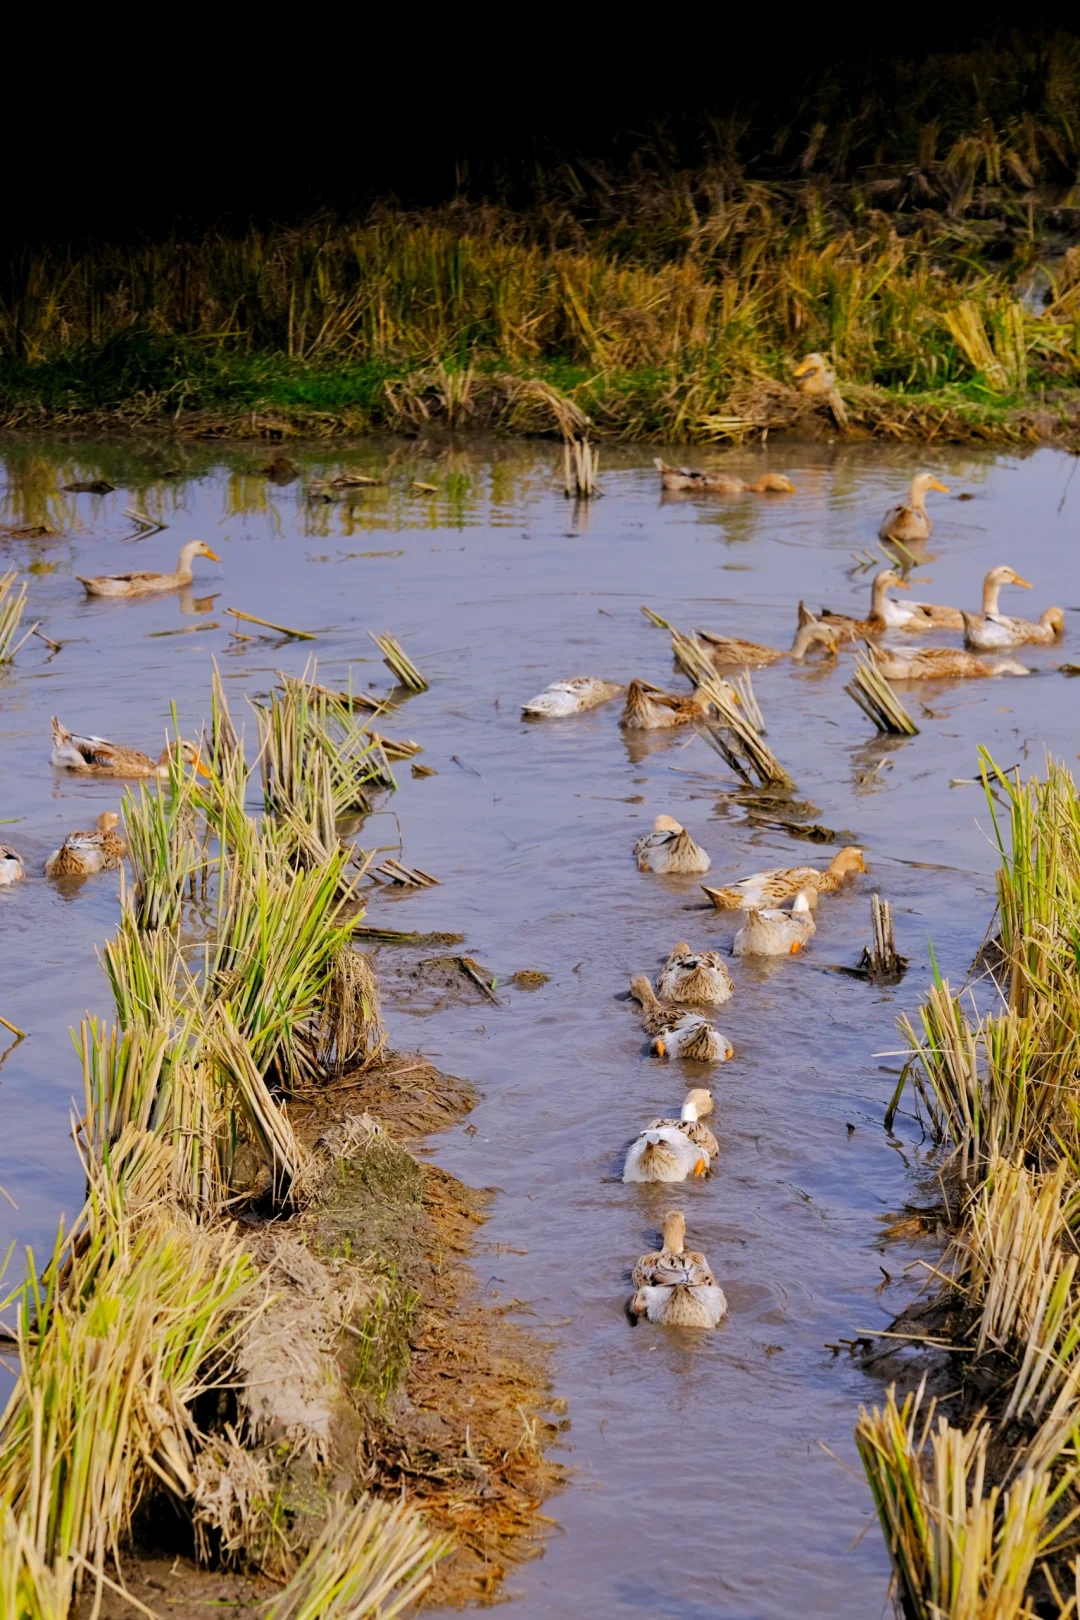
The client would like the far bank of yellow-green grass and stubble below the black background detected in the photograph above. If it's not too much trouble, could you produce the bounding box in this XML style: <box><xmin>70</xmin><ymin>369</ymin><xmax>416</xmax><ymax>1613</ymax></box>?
<box><xmin>10</xmin><ymin>34</ymin><xmax>1080</xmax><ymax>446</ymax></box>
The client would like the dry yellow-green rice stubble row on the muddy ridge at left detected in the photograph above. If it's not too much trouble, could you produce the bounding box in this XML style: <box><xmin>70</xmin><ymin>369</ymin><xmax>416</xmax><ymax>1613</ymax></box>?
<box><xmin>0</xmin><ymin>667</ymin><xmax>466</xmax><ymax>1620</ymax></box>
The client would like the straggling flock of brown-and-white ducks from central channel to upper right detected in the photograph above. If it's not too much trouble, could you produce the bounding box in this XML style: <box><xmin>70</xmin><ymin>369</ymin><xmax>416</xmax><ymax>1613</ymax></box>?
<box><xmin>523</xmin><ymin>453</ymin><xmax>1064</xmax><ymax>1328</ymax></box>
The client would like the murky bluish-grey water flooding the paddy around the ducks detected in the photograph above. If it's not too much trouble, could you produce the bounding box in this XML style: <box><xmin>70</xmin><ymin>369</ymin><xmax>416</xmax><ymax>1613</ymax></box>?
<box><xmin>0</xmin><ymin>441</ymin><xmax>1080</xmax><ymax>1620</ymax></box>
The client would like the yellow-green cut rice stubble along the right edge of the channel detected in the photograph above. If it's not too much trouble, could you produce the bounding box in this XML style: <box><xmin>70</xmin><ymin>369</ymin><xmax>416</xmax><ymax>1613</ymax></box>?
<box><xmin>857</xmin><ymin>753</ymin><xmax>1080</xmax><ymax>1620</ymax></box>
